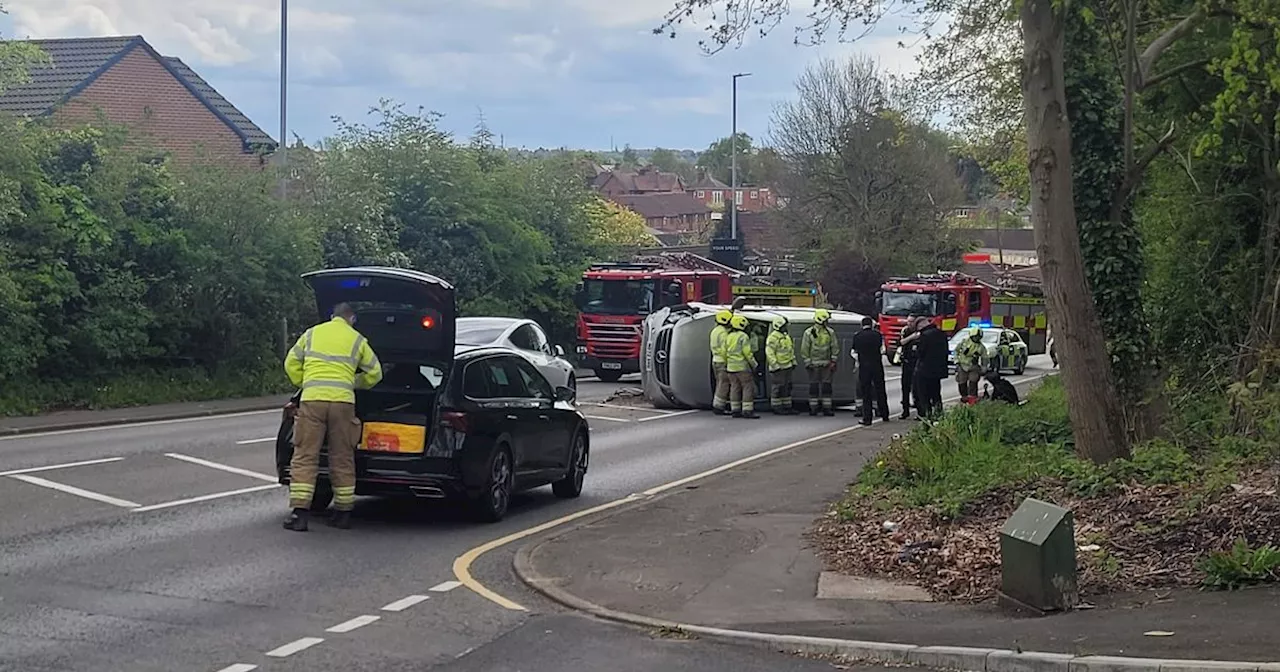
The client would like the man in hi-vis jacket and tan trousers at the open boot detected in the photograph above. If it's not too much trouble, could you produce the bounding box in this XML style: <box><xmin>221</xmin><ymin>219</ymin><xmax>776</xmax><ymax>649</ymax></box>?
<box><xmin>284</xmin><ymin>303</ymin><xmax>383</xmax><ymax>532</ymax></box>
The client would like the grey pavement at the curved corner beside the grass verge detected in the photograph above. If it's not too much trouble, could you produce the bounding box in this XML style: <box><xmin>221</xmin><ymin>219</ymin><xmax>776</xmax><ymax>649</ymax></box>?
<box><xmin>516</xmin><ymin>376</ymin><xmax>1280</xmax><ymax>671</ymax></box>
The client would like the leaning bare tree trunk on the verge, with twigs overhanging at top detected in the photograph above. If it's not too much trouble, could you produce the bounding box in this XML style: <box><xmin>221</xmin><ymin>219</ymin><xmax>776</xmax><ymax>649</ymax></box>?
<box><xmin>655</xmin><ymin>0</ymin><xmax>1129</xmax><ymax>462</ymax></box>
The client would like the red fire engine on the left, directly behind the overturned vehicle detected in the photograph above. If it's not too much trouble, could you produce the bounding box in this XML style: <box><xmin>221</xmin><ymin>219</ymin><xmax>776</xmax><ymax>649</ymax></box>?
<box><xmin>577</xmin><ymin>262</ymin><xmax>735</xmax><ymax>383</ymax></box>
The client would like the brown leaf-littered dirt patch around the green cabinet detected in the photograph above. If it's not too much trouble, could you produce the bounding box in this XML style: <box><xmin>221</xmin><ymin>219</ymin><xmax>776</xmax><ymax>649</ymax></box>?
<box><xmin>808</xmin><ymin>465</ymin><xmax>1280</xmax><ymax>602</ymax></box>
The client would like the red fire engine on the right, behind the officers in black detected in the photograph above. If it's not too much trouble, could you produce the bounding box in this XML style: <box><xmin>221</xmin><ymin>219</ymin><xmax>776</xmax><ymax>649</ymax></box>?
<box><xmin>876</xmin><ymin>273</ymin><xmax>991</xmax><ymax>361</ymax></box>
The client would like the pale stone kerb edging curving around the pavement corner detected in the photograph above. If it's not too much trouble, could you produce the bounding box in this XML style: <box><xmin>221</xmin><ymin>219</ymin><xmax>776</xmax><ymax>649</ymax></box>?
<box><xmin>512</xmin><ymin>404</ymin><xmax>1280</xmax><ymax>672</ymax></box>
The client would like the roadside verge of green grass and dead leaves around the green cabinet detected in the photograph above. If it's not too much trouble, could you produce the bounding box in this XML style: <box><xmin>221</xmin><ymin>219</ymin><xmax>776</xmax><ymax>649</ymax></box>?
<box><xmin>812</xmin><ymin>378</ymin><xmax>1280</xmax><ymax>602</ymax></box>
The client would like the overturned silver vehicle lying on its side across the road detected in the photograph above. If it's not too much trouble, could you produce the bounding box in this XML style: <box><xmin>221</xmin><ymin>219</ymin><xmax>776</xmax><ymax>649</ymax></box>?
<box><xmin>640</xmin><ymin>303</ymin><xmax>863</xmax><ymax>408</ymax></box>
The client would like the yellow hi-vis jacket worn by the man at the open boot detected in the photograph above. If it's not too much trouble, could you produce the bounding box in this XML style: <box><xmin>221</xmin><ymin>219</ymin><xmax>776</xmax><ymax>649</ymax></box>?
<box><xmin>284</xmin><ymin>317</ymin><xmax>383</xmax><ymax>403</ymax></box>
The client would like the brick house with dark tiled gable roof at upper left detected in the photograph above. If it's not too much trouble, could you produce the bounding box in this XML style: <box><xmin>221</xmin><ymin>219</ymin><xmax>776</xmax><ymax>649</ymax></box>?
<box><xmin>0</xmin><ymin>36</ymin><xmax>276</xmax><ymax>166</ymax></box>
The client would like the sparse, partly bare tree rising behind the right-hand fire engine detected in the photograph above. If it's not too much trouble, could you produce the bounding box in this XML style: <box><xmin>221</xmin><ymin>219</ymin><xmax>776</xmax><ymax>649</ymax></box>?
<box><xmin>772</xmin><ymin>58</ymin><xmax>964</xmax><ymax>310</ymax></box>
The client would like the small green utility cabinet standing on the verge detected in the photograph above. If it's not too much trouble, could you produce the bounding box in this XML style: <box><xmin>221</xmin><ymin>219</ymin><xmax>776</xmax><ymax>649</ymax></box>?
<box><xmin>1000</xmin><ymin>497</ymin><xmax>1080</xmax><ymax>614</ymax></box>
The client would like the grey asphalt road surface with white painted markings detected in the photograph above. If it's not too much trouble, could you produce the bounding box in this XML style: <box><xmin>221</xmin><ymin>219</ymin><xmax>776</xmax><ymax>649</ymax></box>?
<box><xmin>0</xmin><ymin>358</ymin><xmax>1042</xmax><ymax>672</ymax></box>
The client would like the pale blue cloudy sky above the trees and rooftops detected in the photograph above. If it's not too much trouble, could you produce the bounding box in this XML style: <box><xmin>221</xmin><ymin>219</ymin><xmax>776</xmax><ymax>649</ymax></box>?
<box><xmin>0</xmin><ymin>0</ymin><xmax>918</xmax><ymax>150</ymax></box>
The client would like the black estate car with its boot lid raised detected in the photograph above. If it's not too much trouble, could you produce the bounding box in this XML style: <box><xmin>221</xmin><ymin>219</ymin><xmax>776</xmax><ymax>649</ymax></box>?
<box><xmin>275</xmin><ymin>268</ymin><xmax>590</xmax><ymax>521</ymax></box>
